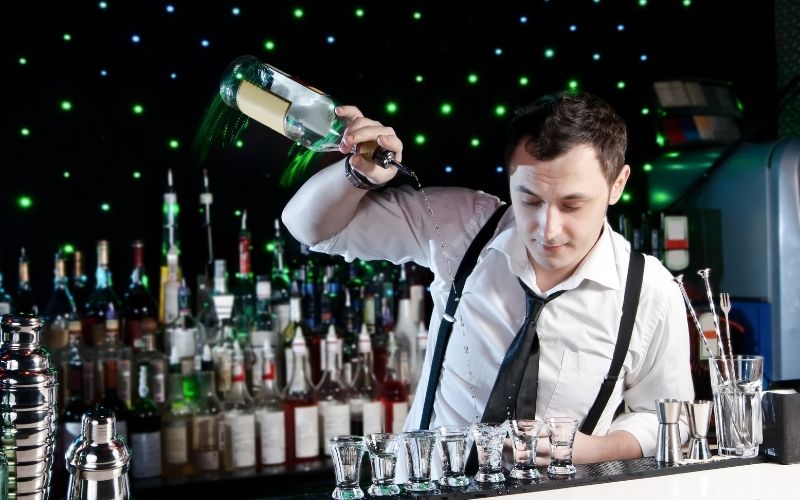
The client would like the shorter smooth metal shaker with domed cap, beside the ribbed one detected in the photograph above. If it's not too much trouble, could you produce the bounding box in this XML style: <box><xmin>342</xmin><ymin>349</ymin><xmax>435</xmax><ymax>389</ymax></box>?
<box><xmin>66</xmin><ymin>407</ymin><xmax>131</xmax><ymax>500</ymax></box>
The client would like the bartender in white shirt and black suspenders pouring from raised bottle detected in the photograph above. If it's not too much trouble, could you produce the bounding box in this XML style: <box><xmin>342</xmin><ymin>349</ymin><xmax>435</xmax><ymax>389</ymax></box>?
<box><xmin>283</xmin><ymin>91</ymin><xmax>694</xmax><ymax>481</ymax></box>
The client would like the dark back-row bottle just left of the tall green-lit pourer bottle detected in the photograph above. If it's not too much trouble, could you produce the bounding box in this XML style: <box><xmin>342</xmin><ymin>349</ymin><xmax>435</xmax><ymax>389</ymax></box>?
<box><xmin>122</xmin><ymin>240</ymin><xmax>158</xmax><ymax>352</ymax></box>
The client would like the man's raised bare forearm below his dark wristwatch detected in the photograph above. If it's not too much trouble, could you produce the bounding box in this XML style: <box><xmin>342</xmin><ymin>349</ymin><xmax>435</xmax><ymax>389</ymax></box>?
<box><xmin>281</xmin><ymin>160</ymin><xmax>367</xmax><ymax>245</ymax></box>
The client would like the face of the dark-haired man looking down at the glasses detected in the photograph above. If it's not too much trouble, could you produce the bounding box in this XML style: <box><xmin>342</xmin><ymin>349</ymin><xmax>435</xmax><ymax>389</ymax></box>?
<box><xmin>509</xmin><ymin>140</ymin><xmax>630</xmax><ymax>291</ymax></box>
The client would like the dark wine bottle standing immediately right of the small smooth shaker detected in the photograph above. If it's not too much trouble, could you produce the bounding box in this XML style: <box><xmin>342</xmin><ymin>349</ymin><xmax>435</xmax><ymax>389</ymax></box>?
<box><xmin>129</xmin><ymin>362</ymin><xmax>161</xmax><ymax>479</ymax></box>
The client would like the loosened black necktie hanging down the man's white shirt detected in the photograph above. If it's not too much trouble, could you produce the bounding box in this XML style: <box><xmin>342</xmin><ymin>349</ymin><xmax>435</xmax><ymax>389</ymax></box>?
<box><xmin>467</xmin><ymin>280</ymin><xmax>564</xmax><ymax>473</ymax></box>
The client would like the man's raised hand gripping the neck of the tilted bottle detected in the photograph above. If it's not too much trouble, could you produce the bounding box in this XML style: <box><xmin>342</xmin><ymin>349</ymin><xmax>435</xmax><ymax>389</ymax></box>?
<box><xmin>335</xmin><ymin>106</ymin><xmax>403</xmax><ymax>184</ymax></box>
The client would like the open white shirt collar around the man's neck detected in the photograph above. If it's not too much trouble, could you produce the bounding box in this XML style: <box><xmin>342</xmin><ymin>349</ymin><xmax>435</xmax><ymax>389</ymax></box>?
<box><xmin>488</xmin><ymin>217</ymin><xmax>620</xmax><ymax>291</ymax></box>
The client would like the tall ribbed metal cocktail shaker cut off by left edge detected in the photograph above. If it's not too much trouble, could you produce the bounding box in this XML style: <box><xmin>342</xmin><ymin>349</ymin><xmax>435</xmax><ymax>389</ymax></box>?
<box><xmin>0</xmin><ymin>314</ymin><xmax>58</xmax><ymax>500</ymax></box>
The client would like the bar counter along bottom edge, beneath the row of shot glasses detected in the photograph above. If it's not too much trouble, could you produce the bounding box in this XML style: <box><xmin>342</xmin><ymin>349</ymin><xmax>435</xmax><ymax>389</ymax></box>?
<box><xmin>133</xmin><ymin>457</ymin><xmax>800</xmax><ymax>500</ymax></box>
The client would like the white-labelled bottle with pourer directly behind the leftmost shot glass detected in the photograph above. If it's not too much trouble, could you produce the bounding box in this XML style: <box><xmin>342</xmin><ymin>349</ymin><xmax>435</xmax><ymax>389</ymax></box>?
<box><xmin>317</xmin><ymin>325</ymin><xmax>350</xmax><ymax>455</ymax></box>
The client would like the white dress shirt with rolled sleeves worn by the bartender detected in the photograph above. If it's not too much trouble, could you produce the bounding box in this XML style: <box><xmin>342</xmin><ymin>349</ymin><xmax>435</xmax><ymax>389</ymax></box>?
<box><xmin>312</xmin><ymin>186</ymin><xmax>694</xmax><ymax>482</ymax></box>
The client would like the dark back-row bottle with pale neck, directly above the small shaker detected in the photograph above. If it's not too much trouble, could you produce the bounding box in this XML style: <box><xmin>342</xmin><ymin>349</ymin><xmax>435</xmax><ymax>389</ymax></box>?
<box><xmin>81</xmin><ymin>240</ymin><xmax>121</xmax><ymax>346</ymax></box>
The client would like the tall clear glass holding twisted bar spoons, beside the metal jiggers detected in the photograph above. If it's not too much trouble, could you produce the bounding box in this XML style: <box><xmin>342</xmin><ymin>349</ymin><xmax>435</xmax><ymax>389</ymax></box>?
<box><xmin>708</xmin><ymin>355</ymin><xmax>764</xmax><ymax>458</ymax></box>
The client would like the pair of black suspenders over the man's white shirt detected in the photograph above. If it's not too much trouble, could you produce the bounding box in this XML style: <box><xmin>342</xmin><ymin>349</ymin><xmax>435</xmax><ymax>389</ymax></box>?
<box><xmin>419</xmin><ymin>204</ymin><xmax>644</xmax><ymax>434</ymax></box>
